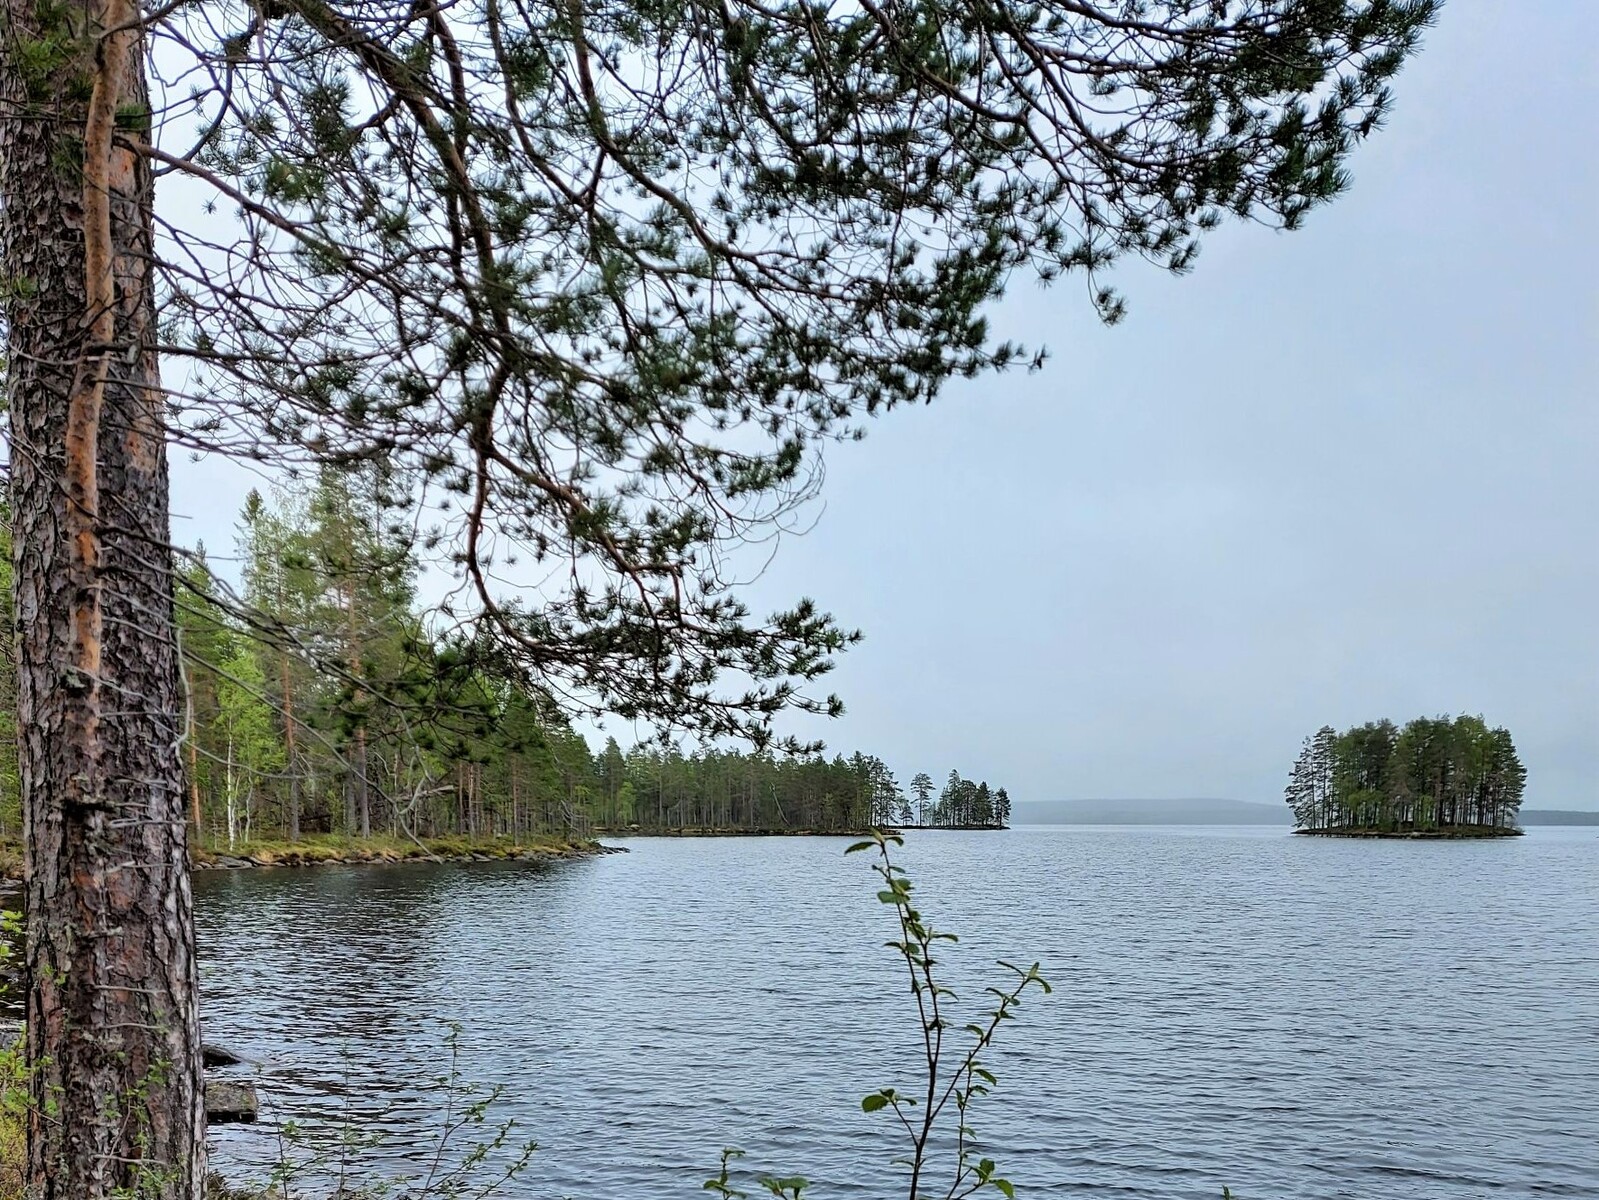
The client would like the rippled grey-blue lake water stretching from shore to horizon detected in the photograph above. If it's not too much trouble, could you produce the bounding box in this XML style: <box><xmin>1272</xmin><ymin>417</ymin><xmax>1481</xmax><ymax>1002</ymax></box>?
<box><xmin>197</xmin><ymin>827</ymin><xmax>1599</xmax><ymax>1200</ymax></box>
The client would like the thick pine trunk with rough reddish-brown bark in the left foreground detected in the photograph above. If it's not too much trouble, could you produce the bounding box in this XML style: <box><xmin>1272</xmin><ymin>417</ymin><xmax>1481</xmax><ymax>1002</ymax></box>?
<box><xmin>0</xmin><ymin>0</ymin><xmax>205</xmax><ymax>1200</ymax></box>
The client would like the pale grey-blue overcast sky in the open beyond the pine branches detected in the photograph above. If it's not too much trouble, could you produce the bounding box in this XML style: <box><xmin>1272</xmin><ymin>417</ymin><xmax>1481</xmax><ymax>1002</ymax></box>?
<box><xmin>173</xmin><ymin>0</ymin><xmax>1599</xmax><ymax>808</ymax></box>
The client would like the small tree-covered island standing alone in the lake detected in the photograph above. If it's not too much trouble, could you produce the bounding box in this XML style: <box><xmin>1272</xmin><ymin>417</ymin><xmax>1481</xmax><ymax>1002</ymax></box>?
<box><xmin>1286</xmin><ymin>717</ymin><xmax>1527</xmax><ymax>837</ymax></box>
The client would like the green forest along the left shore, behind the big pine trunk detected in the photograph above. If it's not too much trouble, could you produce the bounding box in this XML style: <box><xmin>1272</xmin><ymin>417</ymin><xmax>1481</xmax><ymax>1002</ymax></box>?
<box><xmin>0</xmin><ymin>467</ymin><xmax>1011</xmax><ymax>850</ymax></box>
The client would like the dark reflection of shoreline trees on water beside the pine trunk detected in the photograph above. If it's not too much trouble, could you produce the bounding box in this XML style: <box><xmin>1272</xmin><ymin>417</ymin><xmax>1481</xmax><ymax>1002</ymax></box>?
<box><xmin>195</xmin><ymin>864</ymin><xmax>575</xmax><ymax>1152</ymax></box>
